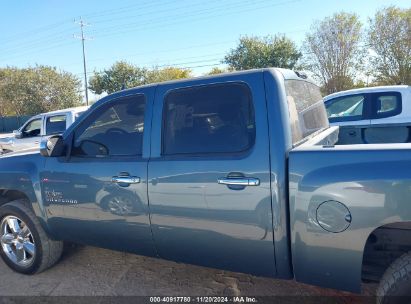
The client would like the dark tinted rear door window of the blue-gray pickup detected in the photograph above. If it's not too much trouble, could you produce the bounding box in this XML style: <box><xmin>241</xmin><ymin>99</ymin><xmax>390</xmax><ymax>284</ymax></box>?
<box><xmin>163</xmin><ymin>83</ymin><xmax>255</xmax><ymax>155</ymax></box>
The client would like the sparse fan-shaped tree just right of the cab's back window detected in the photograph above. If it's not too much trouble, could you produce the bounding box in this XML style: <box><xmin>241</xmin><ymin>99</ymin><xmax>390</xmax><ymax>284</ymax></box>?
<box><xmin>303</xmin><ymin>12</ymin><xmax>365</xmax><ymax>94</ymax></box>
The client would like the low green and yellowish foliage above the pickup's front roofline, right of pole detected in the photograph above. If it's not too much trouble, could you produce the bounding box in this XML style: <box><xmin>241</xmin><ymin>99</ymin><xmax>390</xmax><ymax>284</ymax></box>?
<box><xmin>89</xmin><ymin>61</ymin><xmax>191</xmax><ymax>94</ymax></box>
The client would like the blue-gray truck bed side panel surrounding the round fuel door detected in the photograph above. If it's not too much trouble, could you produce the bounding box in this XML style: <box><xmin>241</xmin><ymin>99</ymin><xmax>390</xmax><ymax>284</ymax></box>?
<box><xmin>289</xmin><ymin>144</ymin><xmax>411</xmax><ymax>292</ymax></box>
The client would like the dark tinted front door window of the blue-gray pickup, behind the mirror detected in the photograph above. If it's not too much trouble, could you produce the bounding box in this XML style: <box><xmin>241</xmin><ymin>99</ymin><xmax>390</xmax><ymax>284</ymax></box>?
<box><xmin>73</xmin><ymin>95</ymin><xmax>146</xmax><ymax>157</ymax></box>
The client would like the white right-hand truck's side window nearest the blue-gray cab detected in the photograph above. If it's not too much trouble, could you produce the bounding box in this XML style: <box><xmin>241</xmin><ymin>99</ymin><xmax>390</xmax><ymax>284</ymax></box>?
<box><xmin>326</xmin><ymin>95</ymin><xmax>365</xmax><ymax>121</ymax></box>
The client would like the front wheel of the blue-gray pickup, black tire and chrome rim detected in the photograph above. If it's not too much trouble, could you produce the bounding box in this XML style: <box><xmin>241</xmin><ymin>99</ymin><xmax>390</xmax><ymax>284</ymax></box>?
<box><xmin>0</xmin><ymin>200</ymin><xmax>63</xmax><ymax>274</ymax></box>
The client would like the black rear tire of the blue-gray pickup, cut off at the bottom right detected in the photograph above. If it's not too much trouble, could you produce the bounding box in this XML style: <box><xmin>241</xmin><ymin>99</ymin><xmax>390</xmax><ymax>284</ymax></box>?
<box><xmin>377</xmin><ymin>251</ymin><xmax>411</xmax><ymax>304</ymax></box>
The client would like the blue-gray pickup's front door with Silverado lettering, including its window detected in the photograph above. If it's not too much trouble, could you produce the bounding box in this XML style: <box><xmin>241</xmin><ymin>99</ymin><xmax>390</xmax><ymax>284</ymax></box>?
<box><xmin>41</xmin><ymin>91</ymin><xmax>154</xmax><ymax>255</ymax></box>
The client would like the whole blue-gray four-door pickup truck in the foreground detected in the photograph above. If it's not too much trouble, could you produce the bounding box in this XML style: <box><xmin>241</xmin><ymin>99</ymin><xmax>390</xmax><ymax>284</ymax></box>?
<box><xmin>0</xmin><ymin>69</ymin><xmax>411</xmax><ymax>303</ymax></box>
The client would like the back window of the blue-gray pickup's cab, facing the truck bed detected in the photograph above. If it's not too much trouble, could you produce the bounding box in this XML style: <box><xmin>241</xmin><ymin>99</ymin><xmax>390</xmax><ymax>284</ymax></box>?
<box><xmin>285</xmin><ymin>79</ymin><xmax>328</xmax><ymax>144</ymax></box>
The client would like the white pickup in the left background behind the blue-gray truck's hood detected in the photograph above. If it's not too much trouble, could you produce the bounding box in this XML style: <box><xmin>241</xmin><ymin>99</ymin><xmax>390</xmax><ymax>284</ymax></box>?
<box><xmin>0</xmin><ymin>106</ymin><xmax>88</xmax><ymax>154</ymax></box>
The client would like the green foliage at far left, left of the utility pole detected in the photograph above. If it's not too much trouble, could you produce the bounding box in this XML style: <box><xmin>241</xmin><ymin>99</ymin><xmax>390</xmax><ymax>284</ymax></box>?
<box><xmin>0</xmin><ymin>66</ymin><xmax>81</xmax><ymax>116</ymax></box>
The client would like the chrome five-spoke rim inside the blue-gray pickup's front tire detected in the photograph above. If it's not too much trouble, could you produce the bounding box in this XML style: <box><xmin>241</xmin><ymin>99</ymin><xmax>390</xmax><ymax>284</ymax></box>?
<box><xmin>0</xmin><ymin>215</ymin><xmax>36</xmax><ymax>267</ymax></box>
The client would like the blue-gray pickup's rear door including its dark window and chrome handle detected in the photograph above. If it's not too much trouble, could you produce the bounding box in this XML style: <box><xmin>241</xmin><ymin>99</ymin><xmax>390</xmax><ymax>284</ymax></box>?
<box><xmin>148</xmin><ymin>73</ymin><xmax>275</xmax><ymax>276</ymax></box>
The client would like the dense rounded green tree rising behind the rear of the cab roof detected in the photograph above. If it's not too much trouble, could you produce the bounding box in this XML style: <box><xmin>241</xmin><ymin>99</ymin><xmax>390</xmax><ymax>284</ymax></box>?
<box><xmin>223</xmin><ymin>36</ymin><xmax>302</xmax><ymax>70</ymax></box>
